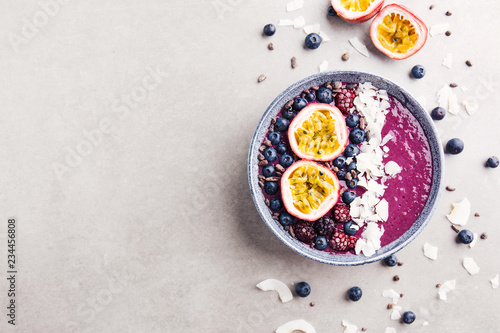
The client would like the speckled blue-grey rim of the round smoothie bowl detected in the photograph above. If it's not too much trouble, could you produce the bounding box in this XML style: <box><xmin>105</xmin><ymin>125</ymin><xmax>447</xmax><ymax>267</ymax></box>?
<box><xmin>248</xmin><ymin>72</ymin><xmax>444</xmax><ymax>266</ymax></box>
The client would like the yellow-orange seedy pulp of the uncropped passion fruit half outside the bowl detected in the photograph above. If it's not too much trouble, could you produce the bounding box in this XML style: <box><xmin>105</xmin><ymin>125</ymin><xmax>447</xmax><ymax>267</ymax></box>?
<box><xmin>378</xmin><ymin>13</ymin><xmax>419</xmax><ymax>53</ymax></box>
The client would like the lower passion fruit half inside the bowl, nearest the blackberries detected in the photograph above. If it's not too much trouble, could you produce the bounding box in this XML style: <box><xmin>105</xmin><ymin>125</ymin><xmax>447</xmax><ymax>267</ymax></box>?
<box><xmin>281</xmin><ymin>160</ymin><xmax>340</xmax><ymax>221</ymax></box>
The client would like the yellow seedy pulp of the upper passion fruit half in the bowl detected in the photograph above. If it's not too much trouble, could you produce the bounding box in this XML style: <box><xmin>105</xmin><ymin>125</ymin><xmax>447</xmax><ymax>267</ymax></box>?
<box><xmin>295</xmin><ymin>110</ymin><xmax>340</xmax><ymax>158</ymax></box>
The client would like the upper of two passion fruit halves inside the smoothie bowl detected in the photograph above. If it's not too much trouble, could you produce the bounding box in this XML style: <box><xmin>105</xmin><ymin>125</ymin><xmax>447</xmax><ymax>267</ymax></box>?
<box><xmin>288</xmin><ymin>103</ymin><xmax>348</xmax><ymax>161</ymax></box>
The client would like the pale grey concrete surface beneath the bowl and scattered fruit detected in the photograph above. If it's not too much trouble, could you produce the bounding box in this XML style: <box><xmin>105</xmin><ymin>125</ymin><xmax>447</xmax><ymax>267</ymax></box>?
<box><xmin>0</xmin><ymin>0</ymin><xmax>500</xmax><ymax>332</ymax></box>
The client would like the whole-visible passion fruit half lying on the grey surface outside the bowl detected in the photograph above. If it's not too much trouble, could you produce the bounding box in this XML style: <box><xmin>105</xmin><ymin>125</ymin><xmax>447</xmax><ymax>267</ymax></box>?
<box><xmin>370</xmin><ymin>4</ymin><xmax>428</xmax><ymax>60</ymax></box>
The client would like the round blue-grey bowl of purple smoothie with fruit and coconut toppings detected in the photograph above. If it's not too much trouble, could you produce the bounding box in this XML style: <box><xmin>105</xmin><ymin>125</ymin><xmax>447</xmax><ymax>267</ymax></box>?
<box><xmin>248</xmin><ymin>72</ymin><xmax>444</xmax><ymax>266</ymax></box>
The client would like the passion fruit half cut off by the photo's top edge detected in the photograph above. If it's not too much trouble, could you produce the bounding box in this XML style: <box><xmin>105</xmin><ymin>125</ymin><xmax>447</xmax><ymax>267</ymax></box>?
<box><xmin>331</xmin><ymin>0</ymin><xmax>384</xmax><ymax>23</ymax></box>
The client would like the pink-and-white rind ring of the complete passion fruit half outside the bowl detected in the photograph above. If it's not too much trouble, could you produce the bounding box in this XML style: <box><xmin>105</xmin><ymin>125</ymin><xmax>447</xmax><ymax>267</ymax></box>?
<box><xmin>370</xmin><ymin>4</ymin><xmax>429</xmax><ymax>60</ymax></box>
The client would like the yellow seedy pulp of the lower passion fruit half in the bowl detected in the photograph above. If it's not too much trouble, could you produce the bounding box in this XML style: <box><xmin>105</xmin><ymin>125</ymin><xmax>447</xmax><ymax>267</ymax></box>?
<box><xmin>289</xmin><ymin>165</ymin><xmax>335</xmax><ymax>214</ymax></box>
